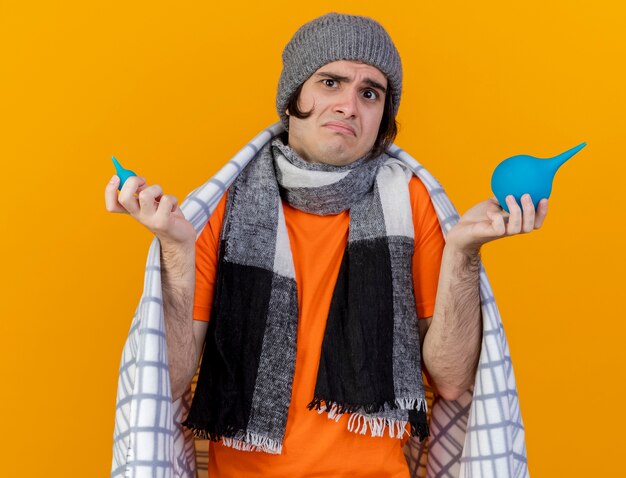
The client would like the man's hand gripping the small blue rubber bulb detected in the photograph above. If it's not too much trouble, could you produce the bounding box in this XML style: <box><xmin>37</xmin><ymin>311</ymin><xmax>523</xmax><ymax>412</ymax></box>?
<box><xmin>104</xmin><ymin>175</ymin><xmax>196</xmax><ymax>248</ymax></box>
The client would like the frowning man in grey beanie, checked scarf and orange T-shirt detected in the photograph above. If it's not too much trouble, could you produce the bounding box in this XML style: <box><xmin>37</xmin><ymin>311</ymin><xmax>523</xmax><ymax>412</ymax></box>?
<box><xmin>105</xmin><ymin>14</ymin><xmax>547</xmax><ymax>477</ymax></box>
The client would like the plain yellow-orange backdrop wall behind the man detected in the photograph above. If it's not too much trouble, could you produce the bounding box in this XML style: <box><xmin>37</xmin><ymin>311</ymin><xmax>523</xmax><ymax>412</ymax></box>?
<box><xmin>0</xmin><ymin>0</ymin><xmax>626</xmax><ymax>477</ymax></box>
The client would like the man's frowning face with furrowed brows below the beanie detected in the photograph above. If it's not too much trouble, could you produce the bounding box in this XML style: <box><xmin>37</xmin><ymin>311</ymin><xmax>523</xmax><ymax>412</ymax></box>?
<box><xmin>287</xmin><ymin>60</ymin><xmax>387</xmax><ymax>166</ymax></box>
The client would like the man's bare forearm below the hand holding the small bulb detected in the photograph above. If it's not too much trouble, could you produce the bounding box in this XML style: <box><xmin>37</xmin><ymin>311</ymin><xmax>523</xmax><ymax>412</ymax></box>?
<box><xmin>161</xmin><ymin>243</ymin><xmax>198</xmax><ymax>400</ymax></box>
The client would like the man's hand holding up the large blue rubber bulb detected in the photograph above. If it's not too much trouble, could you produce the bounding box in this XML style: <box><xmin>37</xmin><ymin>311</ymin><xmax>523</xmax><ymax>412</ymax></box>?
<box><xmin>446</xmin><ymin>194</ymin><xmax>548</xmax><ymax>253</ymax></box>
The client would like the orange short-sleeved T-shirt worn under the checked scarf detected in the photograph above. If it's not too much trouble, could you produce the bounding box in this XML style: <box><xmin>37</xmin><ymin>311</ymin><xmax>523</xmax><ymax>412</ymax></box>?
<box><xmin>194</xmin><ymin>177</ymin><xmax>444</xmax><ymax>478</ymax></box>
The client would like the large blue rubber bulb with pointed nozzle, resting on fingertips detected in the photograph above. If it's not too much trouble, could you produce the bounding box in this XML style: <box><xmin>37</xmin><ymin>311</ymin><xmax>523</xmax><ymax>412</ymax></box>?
<box><xmin>491</xmin><ymin>143</ymin><xmax>587</xmax><ymax>212</ymax></box>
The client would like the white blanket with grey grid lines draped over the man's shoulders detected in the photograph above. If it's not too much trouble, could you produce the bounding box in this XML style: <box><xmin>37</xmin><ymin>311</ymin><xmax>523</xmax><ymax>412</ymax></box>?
<box><xmin>111</xmin><ymin>123</ymin><xmax>528</xmax><ymax>478</ymax></box>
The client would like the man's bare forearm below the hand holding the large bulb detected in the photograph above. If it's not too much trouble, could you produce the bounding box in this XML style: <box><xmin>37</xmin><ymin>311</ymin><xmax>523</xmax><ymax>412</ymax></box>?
<box><xmin>423</xmin><ymin>246</ymin><xmax>482</xmax><ymax>399</ymax></box>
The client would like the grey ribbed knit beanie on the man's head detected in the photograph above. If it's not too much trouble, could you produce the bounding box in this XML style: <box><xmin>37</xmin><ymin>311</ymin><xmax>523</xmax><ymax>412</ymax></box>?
<box><xmin>276</xmin><ymin>13</ymin><xmax>402</xmax><ymax>128</ymax></box>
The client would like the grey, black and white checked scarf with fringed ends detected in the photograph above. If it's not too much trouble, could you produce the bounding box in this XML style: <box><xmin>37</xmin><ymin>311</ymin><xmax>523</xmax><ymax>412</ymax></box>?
<box><xmin>179</xmin><ymin>138</ymin><xmax>428</xmax><ymax>454</ymax></box>
